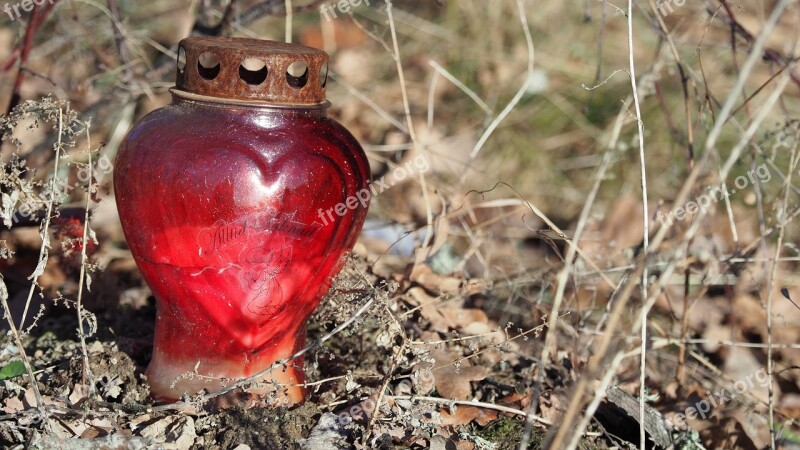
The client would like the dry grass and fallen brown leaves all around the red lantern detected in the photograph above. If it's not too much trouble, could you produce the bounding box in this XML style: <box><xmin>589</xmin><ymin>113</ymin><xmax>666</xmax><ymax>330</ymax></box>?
<box><xmin>0</xmin><ymin>0</ymin><xmax>800</xmax><ymax>449</ymax></box>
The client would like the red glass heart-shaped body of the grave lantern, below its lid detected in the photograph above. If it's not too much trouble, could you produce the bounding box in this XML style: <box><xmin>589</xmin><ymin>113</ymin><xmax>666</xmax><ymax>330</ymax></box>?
<box><xmin>114</xmin><ymin>96</ymin><xmax>369</xmax><ymax>403</ymax></box>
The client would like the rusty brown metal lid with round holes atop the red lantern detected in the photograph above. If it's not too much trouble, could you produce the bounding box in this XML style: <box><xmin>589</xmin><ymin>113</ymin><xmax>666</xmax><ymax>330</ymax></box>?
<box><xmin>175</xmin><ymin>36</ymin><xmax>328</xmax><ymax>106</ymax></box>
